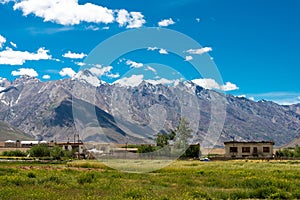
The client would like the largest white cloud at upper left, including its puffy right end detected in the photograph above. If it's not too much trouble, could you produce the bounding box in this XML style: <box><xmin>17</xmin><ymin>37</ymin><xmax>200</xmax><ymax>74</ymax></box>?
<box><xmin>8</xmin><ymin>0</ymin><xmax>146</xmax><ymax>30</ymax></box>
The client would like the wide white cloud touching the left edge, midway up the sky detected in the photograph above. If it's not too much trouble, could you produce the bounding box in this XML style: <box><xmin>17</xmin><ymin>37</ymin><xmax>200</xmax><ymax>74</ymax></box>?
<box><xmin>0</xmin><ymin>47</ymin><xmax>52</xmax><ymax>65</ymax></box>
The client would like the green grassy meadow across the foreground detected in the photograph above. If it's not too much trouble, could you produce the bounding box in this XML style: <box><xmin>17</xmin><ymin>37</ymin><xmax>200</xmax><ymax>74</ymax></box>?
<box><xmin>0</xmin><ymin>161</ymin><xmax>300</xmax><ymax>199</ymax></box>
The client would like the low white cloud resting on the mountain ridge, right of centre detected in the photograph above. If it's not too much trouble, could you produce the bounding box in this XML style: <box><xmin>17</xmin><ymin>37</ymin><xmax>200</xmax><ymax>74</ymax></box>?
<box><xmin>192</xmin><ymin>78</ymin><xmax>239</xmax><ymax>91</ymax></box>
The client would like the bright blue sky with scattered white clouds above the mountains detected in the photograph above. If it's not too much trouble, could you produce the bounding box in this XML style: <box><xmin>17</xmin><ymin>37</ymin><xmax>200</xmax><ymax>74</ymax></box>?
<box><xmin>0</xmin><ymin>0</ymin><xmax>300</xmax><ymax>104</ymax></box>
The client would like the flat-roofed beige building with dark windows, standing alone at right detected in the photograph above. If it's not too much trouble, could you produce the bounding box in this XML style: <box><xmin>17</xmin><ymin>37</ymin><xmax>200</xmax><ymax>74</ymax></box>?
<box><xmin>224</xmin><ymin>141</ymin><xmax>275</xmax><ymax>158</ymax></box>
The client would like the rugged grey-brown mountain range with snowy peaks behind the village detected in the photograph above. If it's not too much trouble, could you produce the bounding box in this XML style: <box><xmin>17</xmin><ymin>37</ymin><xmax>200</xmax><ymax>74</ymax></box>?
<box><xmin>0</xmin><ymin>70</ymin><xmax>300</xmax><ymax>146</ymax></box>
